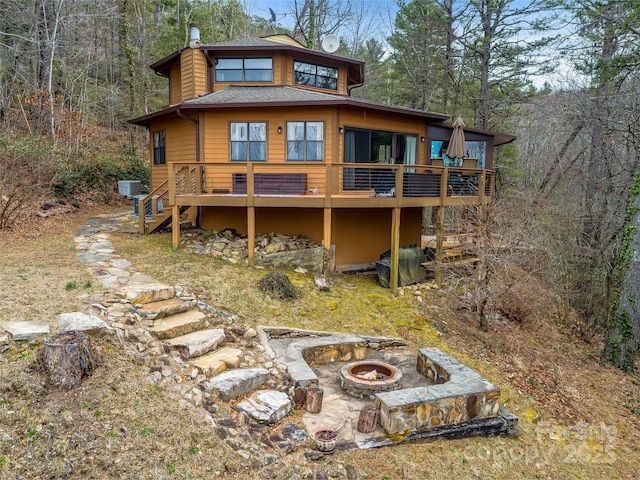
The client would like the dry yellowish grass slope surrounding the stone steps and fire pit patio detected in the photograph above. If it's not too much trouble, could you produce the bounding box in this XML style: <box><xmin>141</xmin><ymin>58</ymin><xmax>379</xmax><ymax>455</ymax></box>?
<box><xmin>0</xmin><ymin>213</ymin><xmax>640</xmax><ymax>480</ymax></box>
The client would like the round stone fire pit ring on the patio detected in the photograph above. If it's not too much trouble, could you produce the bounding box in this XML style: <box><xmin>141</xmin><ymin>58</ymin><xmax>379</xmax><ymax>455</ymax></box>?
<box><xmin>340</xmin><ymin>360</ymin><xmax>402</xmax><ymax>400</ymax></box>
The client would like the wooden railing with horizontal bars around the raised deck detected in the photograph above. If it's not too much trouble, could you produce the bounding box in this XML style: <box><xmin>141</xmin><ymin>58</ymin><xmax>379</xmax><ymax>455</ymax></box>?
<box><xmin>168</xmin><ymin>162</ymin><xmax>495</xmax><ymax>206</ymax></box>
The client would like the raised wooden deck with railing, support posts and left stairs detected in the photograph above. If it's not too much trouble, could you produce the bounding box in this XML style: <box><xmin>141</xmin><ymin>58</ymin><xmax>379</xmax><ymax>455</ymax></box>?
<box><xmin>138</xmin><ymin>162</ymin><xmax>495</xmax><ymax>292</ymax></box>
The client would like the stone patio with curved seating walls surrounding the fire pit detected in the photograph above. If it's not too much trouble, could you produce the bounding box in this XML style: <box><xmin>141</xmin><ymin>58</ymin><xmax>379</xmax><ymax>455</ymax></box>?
<box><xmin>260</xmin><ymin>327</ymin><xmax>517</xmax><ymax>450</ymax></box>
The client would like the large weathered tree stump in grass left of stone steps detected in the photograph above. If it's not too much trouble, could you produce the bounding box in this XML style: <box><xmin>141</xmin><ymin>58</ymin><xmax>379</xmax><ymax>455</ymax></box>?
<box><xmin>42</xmin><ymin>330</ymin><xmax>98</xmax><ymax>390</ymax></box>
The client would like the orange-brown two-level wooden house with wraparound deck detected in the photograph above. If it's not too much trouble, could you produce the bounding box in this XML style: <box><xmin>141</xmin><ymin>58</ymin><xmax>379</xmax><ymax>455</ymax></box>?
<box><xmin>131</xmin><ymin>31</ymin><xmax>515</xmax><ymax>292</ymax></box>
